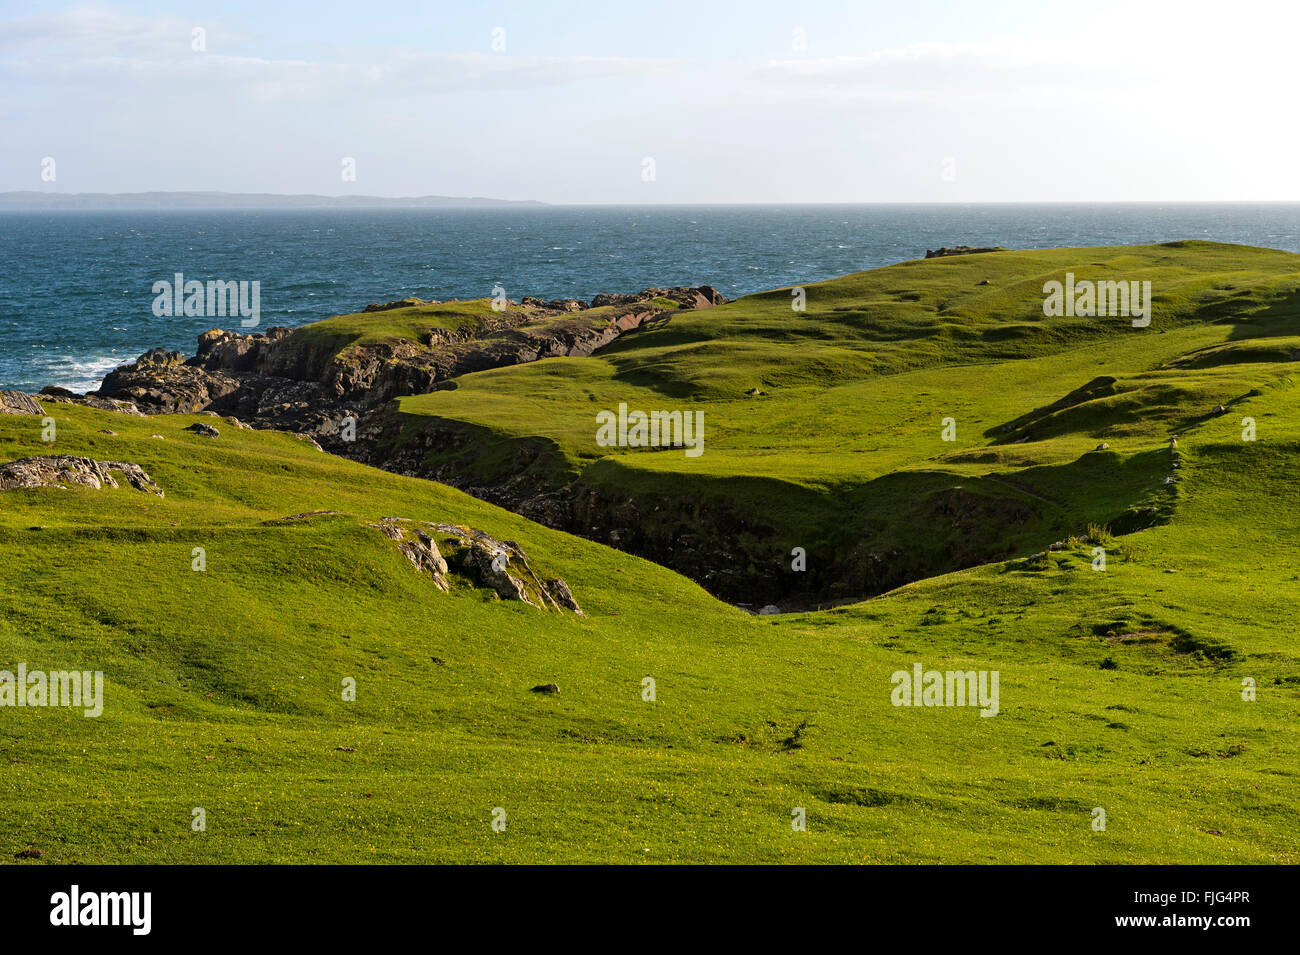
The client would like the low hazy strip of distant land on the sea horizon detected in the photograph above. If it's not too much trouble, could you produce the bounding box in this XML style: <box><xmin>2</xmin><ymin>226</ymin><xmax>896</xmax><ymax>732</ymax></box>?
<box><xmin>0</xmin><ymin>191</ymin><xmax>546</xmax><ymax>209</ymax></box>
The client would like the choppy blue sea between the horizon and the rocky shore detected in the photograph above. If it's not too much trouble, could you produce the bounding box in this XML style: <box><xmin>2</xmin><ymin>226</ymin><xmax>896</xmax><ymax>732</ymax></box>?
<box><xmin>0</xmin><ymin>203</ymin><xmax>1300</xmax><ymax>391</ymax></box>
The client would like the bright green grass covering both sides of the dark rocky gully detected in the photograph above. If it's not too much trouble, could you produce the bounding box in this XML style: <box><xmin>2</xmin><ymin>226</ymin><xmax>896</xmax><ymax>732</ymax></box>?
<box><xmin>0</xmin><ymin>243</ymin><xmax>1300</xmax><ymax>864</ymax></box>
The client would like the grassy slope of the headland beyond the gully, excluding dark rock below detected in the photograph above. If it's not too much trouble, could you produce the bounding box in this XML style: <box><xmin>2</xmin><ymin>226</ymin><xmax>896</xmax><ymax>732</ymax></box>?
<box><xmin>390</xmin><ymin>243</ymin><xmax>1300</xmax><ymax>594</ymax></box>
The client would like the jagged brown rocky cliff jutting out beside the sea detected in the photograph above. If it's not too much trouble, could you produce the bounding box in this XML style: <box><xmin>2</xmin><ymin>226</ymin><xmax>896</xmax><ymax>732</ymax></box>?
<box><xmin>86</xmin><ymin>286</ymin><xmax>725</xmax><ymax>441</ymax></box>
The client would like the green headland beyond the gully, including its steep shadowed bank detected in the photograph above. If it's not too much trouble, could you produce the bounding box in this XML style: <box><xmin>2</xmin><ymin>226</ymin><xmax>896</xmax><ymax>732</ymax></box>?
<box><xmin>372</xmin><ymin>243</ymin><xmax>1300</xmax><ymax>607</ymax></box>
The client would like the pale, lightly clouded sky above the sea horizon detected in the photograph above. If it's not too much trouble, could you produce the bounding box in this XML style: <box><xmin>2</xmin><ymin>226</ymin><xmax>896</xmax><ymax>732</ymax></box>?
<box><xmin>0</xmin><ymin>0</ymin><xmax>1300</xmax><ymax>203</ymax></box>
